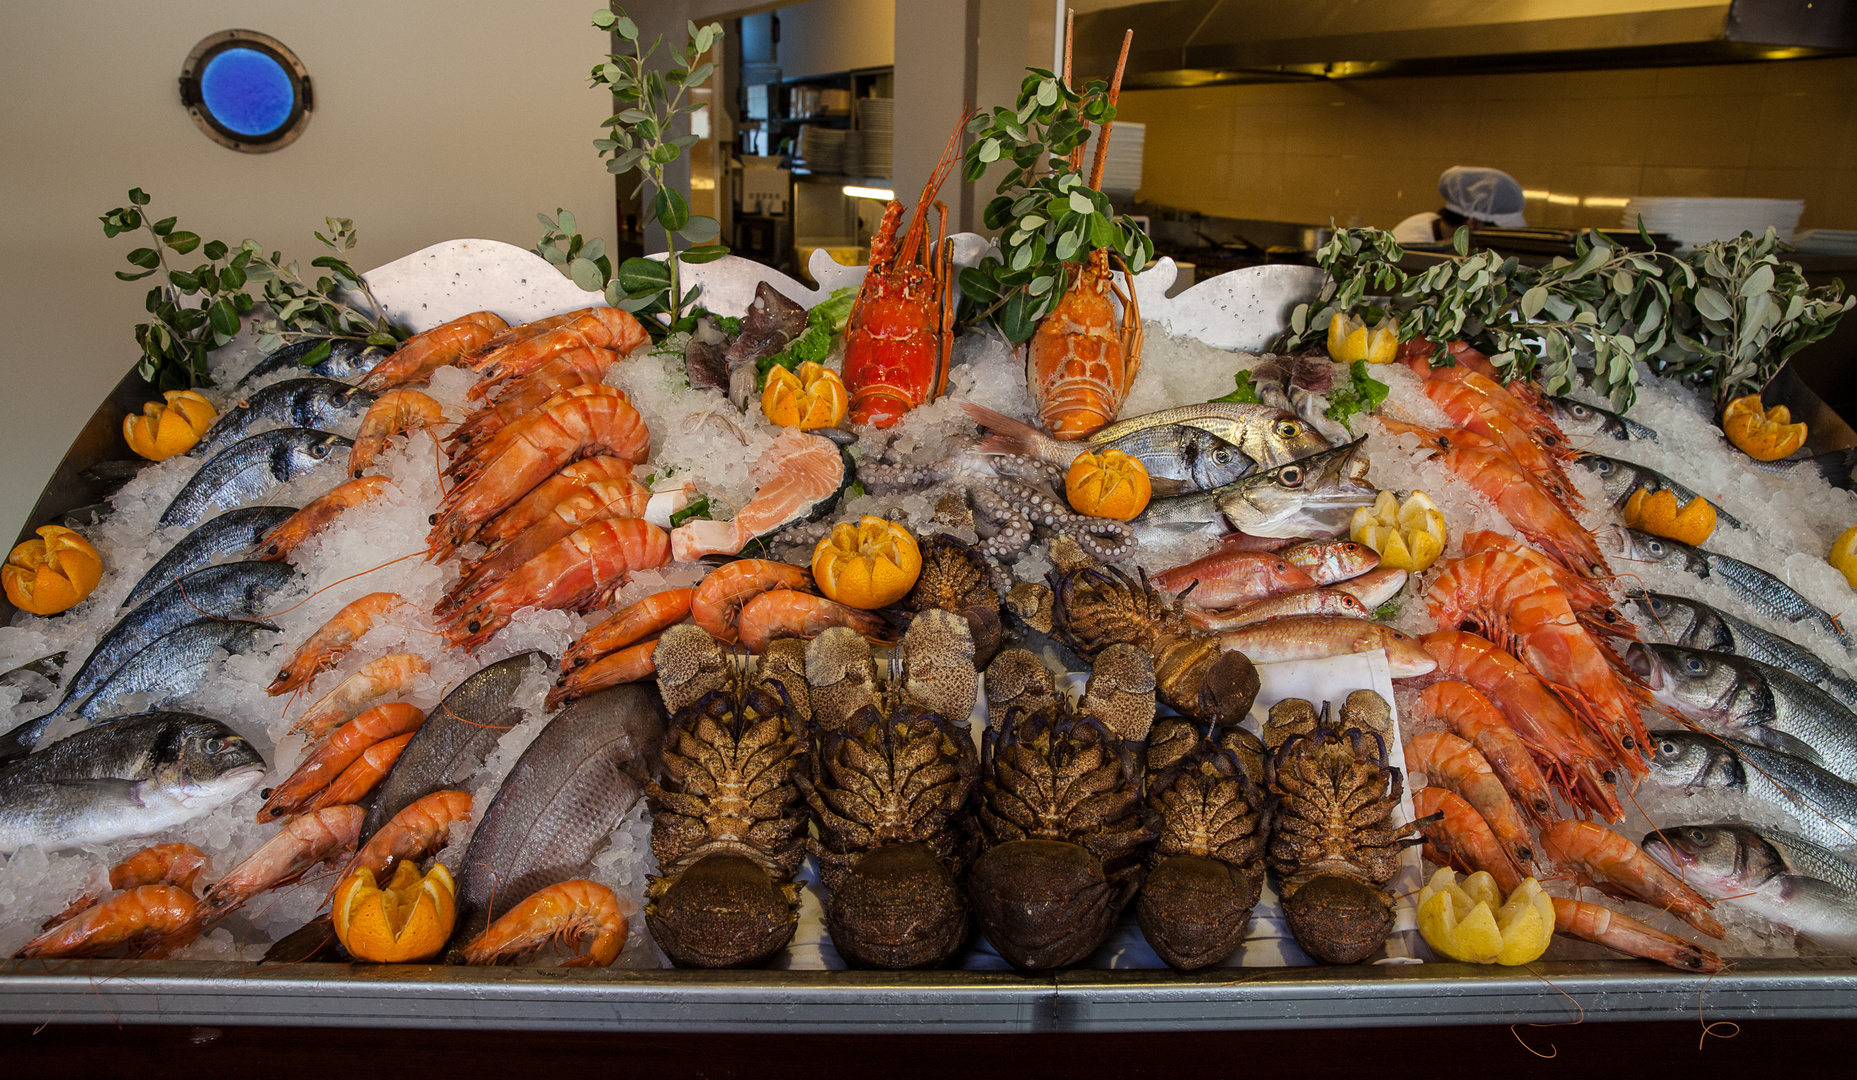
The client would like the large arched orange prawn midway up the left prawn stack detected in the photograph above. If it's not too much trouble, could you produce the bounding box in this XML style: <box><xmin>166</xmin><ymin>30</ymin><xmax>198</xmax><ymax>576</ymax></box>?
<box><xmin>429</xmin><ymin>395</ymin><xmax>652</xmax><ymax>560</ymax></box>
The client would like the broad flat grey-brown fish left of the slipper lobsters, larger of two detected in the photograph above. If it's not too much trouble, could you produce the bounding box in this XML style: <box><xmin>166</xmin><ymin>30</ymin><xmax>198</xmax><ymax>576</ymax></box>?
<box><xmin>453</xmin><ymin>683</ymin><xmax>665</xmax><ymax>941</ymax></box>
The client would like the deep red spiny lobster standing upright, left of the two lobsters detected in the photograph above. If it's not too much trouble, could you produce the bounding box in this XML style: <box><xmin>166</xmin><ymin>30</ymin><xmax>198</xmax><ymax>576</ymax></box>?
<box><xmin>845</xmin><ymin>111</ymin><xmax>969</xmax><ymax>427</ymax></box>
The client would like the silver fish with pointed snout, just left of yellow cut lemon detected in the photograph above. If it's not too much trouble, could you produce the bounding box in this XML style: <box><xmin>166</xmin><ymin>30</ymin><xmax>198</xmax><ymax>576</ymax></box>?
<box><xmin>1135</xmin><ymin>440</ymin><xmax>1374</xmax><ymax>536</ymax></box>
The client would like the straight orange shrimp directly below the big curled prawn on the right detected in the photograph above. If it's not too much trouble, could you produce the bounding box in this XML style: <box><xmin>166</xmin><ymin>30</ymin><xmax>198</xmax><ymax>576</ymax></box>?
<box><xmin>1422</xmin><ymin>631</ymin><xmax>1625</xmax><ymax>822</ymax></box>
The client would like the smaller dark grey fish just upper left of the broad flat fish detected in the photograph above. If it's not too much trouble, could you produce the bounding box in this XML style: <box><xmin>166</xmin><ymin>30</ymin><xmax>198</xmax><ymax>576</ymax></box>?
<box><xmin>360</xmin><ymin>653</ymin><xmax>548</xmax><ymax>842</ymax></box>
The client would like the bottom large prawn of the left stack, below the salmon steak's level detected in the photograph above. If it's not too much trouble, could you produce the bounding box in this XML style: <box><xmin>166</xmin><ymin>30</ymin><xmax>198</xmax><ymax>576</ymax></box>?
<box><xmin>446</xmin><ymin>518</ymin><xmax>670</xmax><ymax>649</ymax></box>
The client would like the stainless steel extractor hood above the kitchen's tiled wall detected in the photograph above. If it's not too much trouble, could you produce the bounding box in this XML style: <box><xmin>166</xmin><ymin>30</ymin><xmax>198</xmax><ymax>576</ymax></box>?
<box><xmin>1077</xmin><ymin>0</ymin><xmax>1857</xmax><ymax>87</ymax></box>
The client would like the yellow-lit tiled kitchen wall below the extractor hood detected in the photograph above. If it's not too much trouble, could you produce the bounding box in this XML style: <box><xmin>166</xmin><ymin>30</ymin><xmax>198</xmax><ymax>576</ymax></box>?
<box><xmin>1120</xmin><ymin>58</ymin><xmax>1857</xmax><ymax>228</ymax></box>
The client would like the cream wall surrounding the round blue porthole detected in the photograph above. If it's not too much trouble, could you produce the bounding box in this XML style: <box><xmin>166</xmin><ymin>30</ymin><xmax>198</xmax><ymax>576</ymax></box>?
<box><xmin>0</xmin><ymin>0</ymin><xmax>617</xmax><ymax>538</ymax></box>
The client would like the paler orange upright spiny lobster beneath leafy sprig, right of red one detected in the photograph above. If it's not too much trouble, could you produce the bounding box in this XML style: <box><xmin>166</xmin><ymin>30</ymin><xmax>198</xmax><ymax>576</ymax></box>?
<box><xmin>1025</xmin><ymin>30</ymin><xmax>1142</xmax><ymax>440</ymax></box>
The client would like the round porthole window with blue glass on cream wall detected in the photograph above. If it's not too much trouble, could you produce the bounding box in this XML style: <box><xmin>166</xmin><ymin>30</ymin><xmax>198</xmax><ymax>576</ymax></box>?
<box><xmin>180</xmin><ymin>30</ymin><xmax>314</xmax><ymax>154</ymax></box>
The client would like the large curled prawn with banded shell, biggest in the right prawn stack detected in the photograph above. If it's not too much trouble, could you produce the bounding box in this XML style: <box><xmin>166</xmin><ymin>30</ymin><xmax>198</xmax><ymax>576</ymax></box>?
<box><xmin>1426</xmin><ymin>551</ymin><xmax>1651</xmax><ymax>776</ymax></box>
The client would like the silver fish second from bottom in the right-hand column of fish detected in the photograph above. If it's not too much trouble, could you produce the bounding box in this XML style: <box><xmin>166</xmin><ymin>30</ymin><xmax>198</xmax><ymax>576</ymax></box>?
<box><xmin>1645</xmin><ymin>731</ymin><xmax>1857</xmax><ymax>848</ymax></box>
